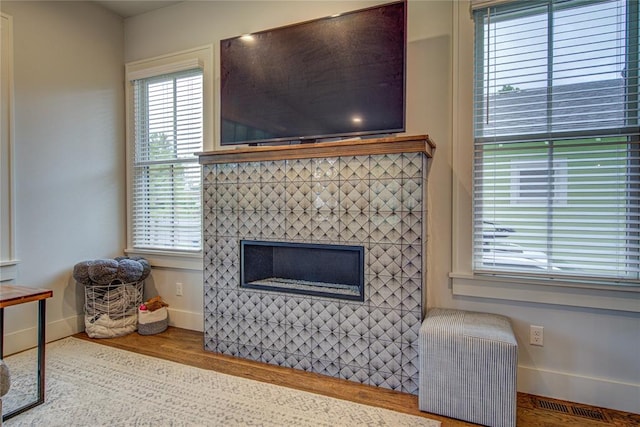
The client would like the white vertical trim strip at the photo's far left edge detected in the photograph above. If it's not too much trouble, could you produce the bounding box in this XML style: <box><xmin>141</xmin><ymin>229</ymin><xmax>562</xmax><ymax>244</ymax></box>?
<box><xmin>0</xmin><ymin>13</ymin><xmax>19</xmax><ymax>282</ymax></box>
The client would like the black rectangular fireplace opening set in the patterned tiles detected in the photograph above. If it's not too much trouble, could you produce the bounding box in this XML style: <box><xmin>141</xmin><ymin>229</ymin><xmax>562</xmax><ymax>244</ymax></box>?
<box><xmin>240</xmin><ymin>240</ymin><xmax>364</xmax><ymax>301</ymax></box>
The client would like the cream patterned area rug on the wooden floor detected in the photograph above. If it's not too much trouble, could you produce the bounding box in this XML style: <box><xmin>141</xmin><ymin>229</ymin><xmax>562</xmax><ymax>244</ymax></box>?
<box><xmin>3</xmin><ymin>337</ymin><xmax>440</xmax><ymax>427</ymax></box>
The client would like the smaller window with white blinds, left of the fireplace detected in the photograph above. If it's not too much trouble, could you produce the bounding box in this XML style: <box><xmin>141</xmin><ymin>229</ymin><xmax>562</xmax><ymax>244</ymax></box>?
<box><xmin>131</xmin><ymin>69</ymin><xmax>203</xmax><ymax>251</ymax></box>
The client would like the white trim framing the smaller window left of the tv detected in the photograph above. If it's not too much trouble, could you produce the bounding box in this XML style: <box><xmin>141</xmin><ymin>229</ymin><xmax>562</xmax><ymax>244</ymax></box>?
<box><xmin>125</xmin><ymin>45</ymin><xmax>214</xmax><ymax>270</ymax></box>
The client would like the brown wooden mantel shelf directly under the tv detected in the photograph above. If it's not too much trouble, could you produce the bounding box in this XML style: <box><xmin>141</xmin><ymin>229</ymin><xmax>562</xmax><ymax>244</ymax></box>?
<box><xmin>198</xmin><ymin>135</ymin><xmax>436</xmax><ymax>165</ymax></box>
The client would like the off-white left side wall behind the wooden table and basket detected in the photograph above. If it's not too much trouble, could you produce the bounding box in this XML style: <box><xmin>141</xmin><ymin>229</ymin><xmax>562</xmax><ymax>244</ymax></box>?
<box><xmin>0</xmin><ymin>1</ymin><xmax>125</xmax><ymax>353</ymax></box>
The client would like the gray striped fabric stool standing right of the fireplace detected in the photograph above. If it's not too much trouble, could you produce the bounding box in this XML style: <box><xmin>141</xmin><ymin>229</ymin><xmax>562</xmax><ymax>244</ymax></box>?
<box><xmin>418</xmin><ymin>308</ymin><xmax>518</xmax><ymax>427</ymax></box>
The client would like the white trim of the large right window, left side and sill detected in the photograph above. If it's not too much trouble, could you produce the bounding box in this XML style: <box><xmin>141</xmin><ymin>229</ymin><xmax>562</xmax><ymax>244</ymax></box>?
<box><xmin>449</xmin><ymin>1</ymin><xmax>640</xmax><ymax>313</ymax></box>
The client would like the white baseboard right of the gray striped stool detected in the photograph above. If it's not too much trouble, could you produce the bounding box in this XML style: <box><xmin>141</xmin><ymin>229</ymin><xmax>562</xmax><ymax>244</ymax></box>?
<box><xmin>518</xmin><ymin>366</ymin><xmax>640</xmax><ymax>414</ymax></box>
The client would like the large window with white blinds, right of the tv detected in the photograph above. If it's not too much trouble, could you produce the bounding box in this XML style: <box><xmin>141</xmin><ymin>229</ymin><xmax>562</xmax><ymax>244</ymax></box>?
<box><xmin>473</xmin><ymin>0</ymin><xmax>640</xmax><ymax>284</ymax></box>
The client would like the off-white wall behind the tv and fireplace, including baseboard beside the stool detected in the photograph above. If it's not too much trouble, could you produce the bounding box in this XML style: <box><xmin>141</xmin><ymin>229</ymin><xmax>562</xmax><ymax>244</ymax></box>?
<box><xmin>125</xmin><ymin>0</ymin><xmax>640</xmax><ymax>412</ymax></box>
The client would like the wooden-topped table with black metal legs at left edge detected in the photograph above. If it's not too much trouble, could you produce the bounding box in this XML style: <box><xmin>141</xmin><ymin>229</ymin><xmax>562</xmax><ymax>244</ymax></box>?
<box><xmin>0</xmin><ymin>285</ymin><xmax>53</xmax><ymax>421</ymax></box>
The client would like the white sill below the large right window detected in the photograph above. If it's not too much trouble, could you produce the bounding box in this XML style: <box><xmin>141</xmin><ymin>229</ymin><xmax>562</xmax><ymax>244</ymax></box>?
<box><xmin>449</xmin><ymin>273</ymin><xmax>640</xmax><ymax>313</ymax></box>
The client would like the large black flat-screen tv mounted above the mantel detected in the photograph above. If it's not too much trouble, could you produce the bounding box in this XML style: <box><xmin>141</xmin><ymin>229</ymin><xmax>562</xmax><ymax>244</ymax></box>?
<box><xmin>220</xmin><ymin>1</ymin><xmax>406</xmax><ymax>145</ymax></box>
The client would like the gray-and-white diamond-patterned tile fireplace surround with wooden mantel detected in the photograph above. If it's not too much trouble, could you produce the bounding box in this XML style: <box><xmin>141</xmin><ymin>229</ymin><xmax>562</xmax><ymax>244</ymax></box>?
<box><xmin>200</xmin><ymin>135</ymin><xmax>433</xmax><ymax>394</ymax></box>
